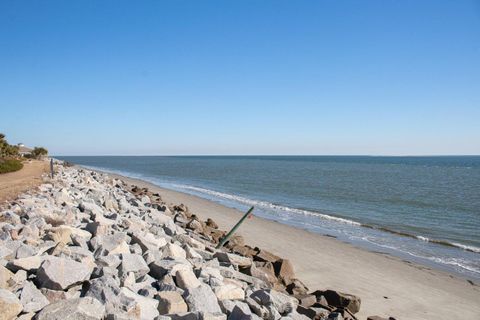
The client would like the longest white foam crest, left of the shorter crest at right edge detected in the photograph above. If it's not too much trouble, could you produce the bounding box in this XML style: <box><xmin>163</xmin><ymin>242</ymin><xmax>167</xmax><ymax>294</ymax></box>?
<box><xmin>172</xmin><ymin>184</ymin><xmax>361</xmax><ymax>226</ymax></box>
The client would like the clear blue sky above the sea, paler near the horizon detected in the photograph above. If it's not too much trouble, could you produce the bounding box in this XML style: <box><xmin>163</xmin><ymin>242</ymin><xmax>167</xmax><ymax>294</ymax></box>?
<box><xmin>0</xmin><ymin>0</ymin><xmax>480</xmax><ymax>155</ymax></box>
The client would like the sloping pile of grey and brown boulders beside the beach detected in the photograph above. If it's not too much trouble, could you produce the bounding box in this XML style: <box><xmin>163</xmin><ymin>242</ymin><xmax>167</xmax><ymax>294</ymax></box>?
<box><xmin>0</xmin><ymin>165</ymin><xmax>386</xmax><ymax>320</ymax></box>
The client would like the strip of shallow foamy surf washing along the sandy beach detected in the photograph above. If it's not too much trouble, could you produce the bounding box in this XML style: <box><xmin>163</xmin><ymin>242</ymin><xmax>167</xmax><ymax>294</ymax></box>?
<box><xmin>70</xmin><ymin>166</ymin><xmax>480</xmax><ymax>284</ymax></box>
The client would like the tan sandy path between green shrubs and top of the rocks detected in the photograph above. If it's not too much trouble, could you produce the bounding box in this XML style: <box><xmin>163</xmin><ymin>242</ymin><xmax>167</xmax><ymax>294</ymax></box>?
<box><xmin>0</xmin><ymin>160</ymin><xmax>49</xmax><ymax>204</ymax></box>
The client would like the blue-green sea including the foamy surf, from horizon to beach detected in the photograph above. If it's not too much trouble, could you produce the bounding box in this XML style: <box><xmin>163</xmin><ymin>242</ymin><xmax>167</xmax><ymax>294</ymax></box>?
<box><xmin>58</xmin><ymin>156</ymin><xmax>480</xmax><ymax>280</ymax></box>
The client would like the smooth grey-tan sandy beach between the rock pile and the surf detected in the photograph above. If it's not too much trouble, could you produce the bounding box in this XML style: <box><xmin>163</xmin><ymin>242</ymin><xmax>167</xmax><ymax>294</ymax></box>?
<box><xmin>113</xmin><ymin>175</ymin><xmax>480</xmax><ymax>320</ymax></box>
